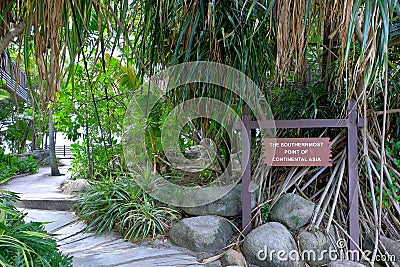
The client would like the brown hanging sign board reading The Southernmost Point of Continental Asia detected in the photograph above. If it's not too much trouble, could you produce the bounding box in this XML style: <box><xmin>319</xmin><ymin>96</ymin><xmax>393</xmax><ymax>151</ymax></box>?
<box><xmin>263</xmin><ymin>138</ymin><xmax>332</xmax><ymax>166</ymax></box>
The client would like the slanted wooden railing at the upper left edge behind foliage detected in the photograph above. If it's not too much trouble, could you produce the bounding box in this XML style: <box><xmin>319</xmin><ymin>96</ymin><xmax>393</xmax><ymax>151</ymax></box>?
<box><xmin>0</xmin><ymin>53</ymin><xmax>30</xmax><ymax>101</ymax></box>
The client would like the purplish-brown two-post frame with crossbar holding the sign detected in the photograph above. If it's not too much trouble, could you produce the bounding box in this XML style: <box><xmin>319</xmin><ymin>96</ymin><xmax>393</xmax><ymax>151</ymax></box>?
<box><xmin>237</xmin><ymin>100</ymin><xmax>364</xmax><ymax>251</ymax></box>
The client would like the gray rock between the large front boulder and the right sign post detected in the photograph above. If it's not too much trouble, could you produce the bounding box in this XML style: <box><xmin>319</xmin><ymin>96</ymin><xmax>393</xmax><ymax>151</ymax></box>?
<box><xmin>299</xmin><ymin>231</ymin><xmax>338</xmax><ymax>266</ymax></box>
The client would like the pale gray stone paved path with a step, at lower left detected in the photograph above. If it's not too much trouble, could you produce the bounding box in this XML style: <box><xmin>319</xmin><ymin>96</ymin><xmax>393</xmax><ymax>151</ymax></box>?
<box><xmin>2</xmin><ymin>163</ymin><xmax>204</xmax><ymax>267</ymax></box>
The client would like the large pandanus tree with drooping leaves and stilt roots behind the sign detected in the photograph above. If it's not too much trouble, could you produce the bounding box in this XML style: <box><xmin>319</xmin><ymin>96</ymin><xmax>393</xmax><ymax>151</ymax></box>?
<box><xmin>117</xmin><ymin>0</ymin><xmax>400</xmax><ymax>261</ymax></box>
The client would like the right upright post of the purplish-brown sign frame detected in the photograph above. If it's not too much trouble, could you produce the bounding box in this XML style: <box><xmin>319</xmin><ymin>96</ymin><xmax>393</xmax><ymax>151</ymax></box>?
<box><xmin>347</xmin><ymin>99</ymin><xmax>360</xmax><ymax>260</ymax></box>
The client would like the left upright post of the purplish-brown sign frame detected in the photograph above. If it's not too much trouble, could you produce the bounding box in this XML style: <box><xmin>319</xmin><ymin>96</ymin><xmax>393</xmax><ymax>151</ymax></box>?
<box><xmin>242</xmin><ymin>109</ymin><xmax>251</xmax><ymax>235</ymax></box>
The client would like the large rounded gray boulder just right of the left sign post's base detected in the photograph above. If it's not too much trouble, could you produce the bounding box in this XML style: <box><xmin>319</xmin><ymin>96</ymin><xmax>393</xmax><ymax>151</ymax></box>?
<box><xmin>243</xmin><ymin>222</ymin><xmax>304</xmax><ymax>267</ymax></box>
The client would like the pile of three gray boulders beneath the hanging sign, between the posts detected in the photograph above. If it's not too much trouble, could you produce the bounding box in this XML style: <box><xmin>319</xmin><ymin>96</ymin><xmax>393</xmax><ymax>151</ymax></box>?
<box><xmin>243</xmin><ymin>194</ymin><xmax>336</xmax><ymax>267</ymax></box>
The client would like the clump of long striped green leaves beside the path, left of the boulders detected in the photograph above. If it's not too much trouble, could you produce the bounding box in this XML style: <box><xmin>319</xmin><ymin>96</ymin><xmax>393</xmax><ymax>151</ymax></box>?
<box><xmin>75</xmin><ymin>178</ymin><xmax>179</xmax><ymax>243</ymax></box>
